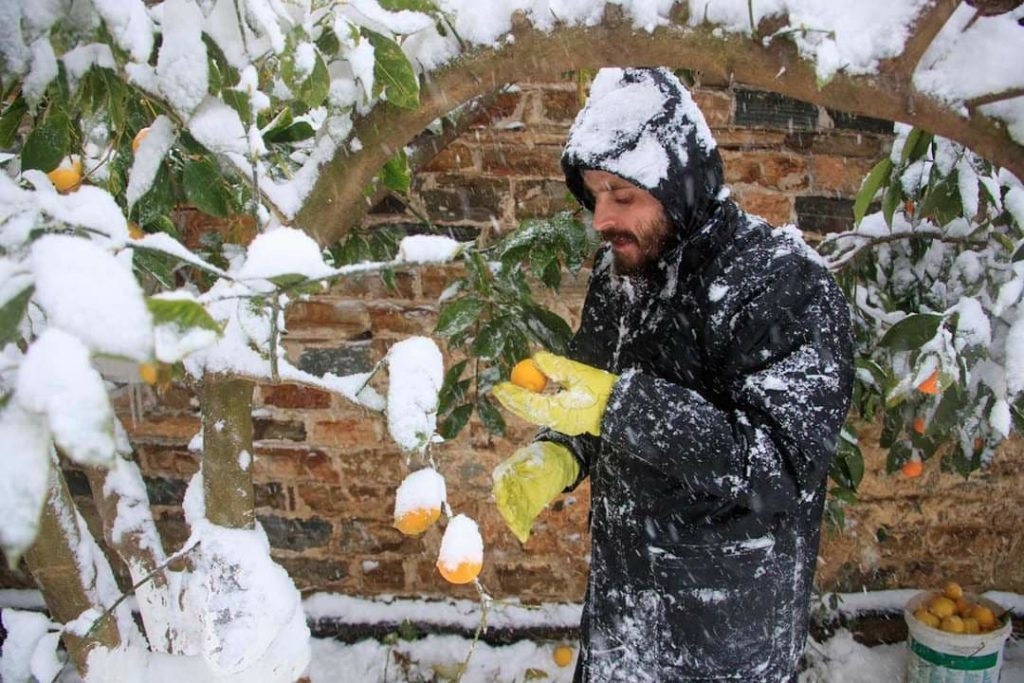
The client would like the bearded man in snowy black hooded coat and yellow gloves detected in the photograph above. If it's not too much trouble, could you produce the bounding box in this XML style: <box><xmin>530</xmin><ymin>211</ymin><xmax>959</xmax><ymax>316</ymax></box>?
<box><xmin>494</xmin><ymin>69</ymin><xmax>852</xmax><ymax>682</ymax></box>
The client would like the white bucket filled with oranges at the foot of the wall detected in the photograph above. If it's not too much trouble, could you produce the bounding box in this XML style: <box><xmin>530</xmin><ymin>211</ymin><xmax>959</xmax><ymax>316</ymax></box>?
<box><xmin>903</xmin><ymin>582</ymin><xmax>1012</xmax><ymax>683</ymax></box>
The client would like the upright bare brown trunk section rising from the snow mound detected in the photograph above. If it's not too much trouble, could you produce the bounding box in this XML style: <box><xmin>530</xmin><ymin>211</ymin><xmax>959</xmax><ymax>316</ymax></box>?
<box><xmin>202</xmin><ymin>374</ymin><xmax>255</xmax><ymax>528</ymax></box>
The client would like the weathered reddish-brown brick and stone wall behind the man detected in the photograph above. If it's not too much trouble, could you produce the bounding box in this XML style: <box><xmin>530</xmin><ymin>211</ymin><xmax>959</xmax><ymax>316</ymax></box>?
<box><xmin>0</xmin><ymin>81</ymin><xmax>1024</xmax><ymax>601</ymax></box>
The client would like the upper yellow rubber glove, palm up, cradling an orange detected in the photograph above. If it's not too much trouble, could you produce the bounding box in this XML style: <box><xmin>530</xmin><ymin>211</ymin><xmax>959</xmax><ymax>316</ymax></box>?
<box><xmin>493</xmin><ymin>351</ymin><xmax>618</xmax><ymax>436</ymax></box>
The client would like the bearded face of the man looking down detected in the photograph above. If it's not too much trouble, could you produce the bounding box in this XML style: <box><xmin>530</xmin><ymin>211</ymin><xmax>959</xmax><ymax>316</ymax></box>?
<box><xmin>583</xmin><ymin>170</ymin><xmax>672</xmax><ymax>275</ymax></box>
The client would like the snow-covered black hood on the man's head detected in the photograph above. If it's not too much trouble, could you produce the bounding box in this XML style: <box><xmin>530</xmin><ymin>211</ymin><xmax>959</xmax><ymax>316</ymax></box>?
<box><xmin>562</xmin><ymin>68</ymin><xmax>723</xmax><ymax>243</ymax></box>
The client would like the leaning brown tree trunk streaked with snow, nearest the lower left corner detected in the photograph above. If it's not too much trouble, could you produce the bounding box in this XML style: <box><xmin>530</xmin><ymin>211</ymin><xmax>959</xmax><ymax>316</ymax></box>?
<box><xmin>25</xmin><ymin>459</ymin><xmax>122</xmax><ymax>677</ymax></box>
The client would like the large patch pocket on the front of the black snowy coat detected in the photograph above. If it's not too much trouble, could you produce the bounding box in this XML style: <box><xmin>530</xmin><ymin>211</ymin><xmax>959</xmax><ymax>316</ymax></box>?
<box><xmin>651</xmin><ymin>536</ymin><xmax>785</xmax><ymax>680</ymax></box>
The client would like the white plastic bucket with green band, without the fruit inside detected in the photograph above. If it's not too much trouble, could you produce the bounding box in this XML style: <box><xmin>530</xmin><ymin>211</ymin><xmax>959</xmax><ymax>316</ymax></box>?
<box><xmin>903</xmin><ymin>591</ymin><xmax>1013</xmax><ymax>683</ymax></box>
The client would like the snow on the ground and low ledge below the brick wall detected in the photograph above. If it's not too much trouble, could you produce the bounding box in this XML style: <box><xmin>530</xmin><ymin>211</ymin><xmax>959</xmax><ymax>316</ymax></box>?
<box><xmin>0</xmin><ymin>590</ymin><xmax>1024</xmax><ymax>683</ymax></box>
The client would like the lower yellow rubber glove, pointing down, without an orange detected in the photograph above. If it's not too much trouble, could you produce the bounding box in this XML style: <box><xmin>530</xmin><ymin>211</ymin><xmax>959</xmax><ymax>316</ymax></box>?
<box><xmin>490</xmin><ymin>441</ymin><xmax>580</xmax><ymax>543</ymax></box>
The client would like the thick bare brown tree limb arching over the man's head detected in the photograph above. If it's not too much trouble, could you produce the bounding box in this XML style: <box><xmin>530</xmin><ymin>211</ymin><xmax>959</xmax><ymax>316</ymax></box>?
<box><xmin>296</xmin><ymin>0</ymin><xmax>1024</xmax><ymax>245</ymax></box>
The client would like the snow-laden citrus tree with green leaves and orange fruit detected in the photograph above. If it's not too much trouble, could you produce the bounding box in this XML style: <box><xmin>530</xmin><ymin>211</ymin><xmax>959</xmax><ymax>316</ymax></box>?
<box><xmin>0</xmin><ymin>0</ymin><xmax>1024</xmax><ymax>681</ymax></box>
